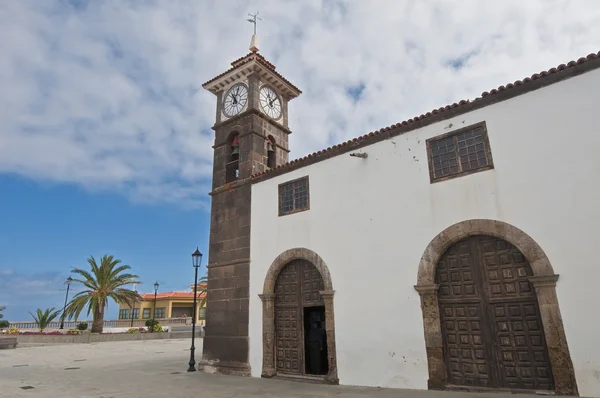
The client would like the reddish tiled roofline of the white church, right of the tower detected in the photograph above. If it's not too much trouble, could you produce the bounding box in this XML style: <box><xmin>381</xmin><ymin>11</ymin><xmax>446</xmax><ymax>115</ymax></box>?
<box><xmin>250</xmin><ymin>51</ymin><xmax>600</xmax><ymax>179</ymax></box>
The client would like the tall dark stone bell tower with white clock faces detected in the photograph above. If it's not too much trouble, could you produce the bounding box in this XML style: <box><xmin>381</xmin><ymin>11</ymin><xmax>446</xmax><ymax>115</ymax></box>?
<box><xmin>200</xmin><ymin>29</ymin><xmax>301</xmax><ymax>376</ymax></box>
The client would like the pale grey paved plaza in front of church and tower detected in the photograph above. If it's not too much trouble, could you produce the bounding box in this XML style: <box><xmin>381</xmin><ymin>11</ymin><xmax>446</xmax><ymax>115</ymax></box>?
<box><xmin>0</xmin><ymin>340</ymin><xmax>580</xmax><ymax>398</ymax></box>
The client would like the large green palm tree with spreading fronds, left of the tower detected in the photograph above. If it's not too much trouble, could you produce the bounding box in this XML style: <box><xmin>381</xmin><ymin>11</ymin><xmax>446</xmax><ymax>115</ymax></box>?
<box><xmin>65</xmin><ymin>254</ymin><xmax>141</xmax><ymax>333</ymax></box>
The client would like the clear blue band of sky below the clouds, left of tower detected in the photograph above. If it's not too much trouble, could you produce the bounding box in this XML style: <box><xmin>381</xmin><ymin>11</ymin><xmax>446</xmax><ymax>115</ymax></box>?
<box><xmin>0</xmin><ymin>175</ymin><xmax>209</xmax><ymax>320</ymax></box>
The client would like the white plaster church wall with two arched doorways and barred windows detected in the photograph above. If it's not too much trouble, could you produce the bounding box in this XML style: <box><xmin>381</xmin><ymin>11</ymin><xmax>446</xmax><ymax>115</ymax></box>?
<box><xmin>250</xmin><ymin>71</ymin><xmax>600</xmax><ymax>396</ymax></box>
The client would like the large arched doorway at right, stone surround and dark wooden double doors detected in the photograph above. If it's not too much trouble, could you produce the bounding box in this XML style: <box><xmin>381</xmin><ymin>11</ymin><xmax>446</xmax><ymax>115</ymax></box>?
<box><xmin>415</xmin><ymin>220</ymin><xmax>578</xmax><ymax>395</ymax></box>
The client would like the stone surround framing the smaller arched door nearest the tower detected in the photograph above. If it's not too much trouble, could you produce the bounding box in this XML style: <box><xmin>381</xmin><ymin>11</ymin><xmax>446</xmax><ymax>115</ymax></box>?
<box><xmin>258</xmin><ymin>248</ymin><xmax>339</xmax><ymax>384</ymax></box>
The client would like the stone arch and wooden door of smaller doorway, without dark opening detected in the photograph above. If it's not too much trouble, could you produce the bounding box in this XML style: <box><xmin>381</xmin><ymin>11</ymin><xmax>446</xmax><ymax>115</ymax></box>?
<box><xmin>259</xmin><ymin>248</ymin><xmax>338</xmax><ymax>384</ymax></box>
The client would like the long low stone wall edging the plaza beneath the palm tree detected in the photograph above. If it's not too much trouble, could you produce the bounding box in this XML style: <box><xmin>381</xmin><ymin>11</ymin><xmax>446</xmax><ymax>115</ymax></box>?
<box><xmin>17</xmin><ymin>332</ymin><xmax>173</xmax><ymax>348</ymax></box>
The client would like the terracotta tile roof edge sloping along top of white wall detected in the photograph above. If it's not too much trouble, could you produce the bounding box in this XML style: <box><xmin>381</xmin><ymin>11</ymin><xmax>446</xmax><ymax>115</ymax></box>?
<box><xmin>250</xmin><ymin>51</ymin><xmax>600</xmax><ymax>179</ymax></box>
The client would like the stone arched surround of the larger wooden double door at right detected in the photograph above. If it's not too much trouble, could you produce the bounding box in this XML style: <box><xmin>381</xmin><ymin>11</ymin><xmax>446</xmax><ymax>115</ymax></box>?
<box><xmin>414</xmin><ymin>219</ymin><xmax>579</xmax><ymax>396</ymax></box>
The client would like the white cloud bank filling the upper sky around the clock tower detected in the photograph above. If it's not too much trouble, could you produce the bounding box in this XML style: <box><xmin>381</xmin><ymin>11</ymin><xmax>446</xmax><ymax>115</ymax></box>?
<box><xmin>0</xmin><ymin>0</ymin><xmax>600</xmax><ymax>206</ymax></box>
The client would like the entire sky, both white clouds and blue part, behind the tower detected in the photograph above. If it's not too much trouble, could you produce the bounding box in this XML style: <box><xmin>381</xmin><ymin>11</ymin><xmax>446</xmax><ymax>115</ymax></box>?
<box><xmin>0</xmin><ymin>0</ymin><xmax>600</xmax><ymax>321</ymax></box>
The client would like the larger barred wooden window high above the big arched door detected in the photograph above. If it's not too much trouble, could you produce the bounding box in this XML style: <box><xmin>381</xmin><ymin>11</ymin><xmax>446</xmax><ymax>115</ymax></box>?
<box><xmin>427</xmin><ymin>122</ymin><xmax>494</xmax><ymax>182</ymax></box>
